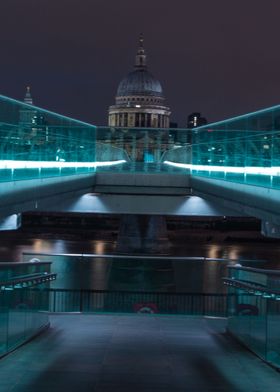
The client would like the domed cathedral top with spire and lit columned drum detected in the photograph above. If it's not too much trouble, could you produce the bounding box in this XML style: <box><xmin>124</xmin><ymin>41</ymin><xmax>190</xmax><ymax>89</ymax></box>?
<box><xmin>108</xmin><ymin>35</ymin><xmax>170</xmax><ymax>128</ymax></box>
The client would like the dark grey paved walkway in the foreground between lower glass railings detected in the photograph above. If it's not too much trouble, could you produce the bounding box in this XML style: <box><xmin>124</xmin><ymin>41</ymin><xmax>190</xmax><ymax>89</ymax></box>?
<box><xmin>0</xmin><ymin>315</ymin><xmax>280</xmax><ymax>392</ymax></box>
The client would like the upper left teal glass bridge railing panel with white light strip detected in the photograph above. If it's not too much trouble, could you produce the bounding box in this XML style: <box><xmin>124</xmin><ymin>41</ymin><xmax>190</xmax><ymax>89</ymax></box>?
<box><xmin>0</xmin><ymin>96</ymin><xmax>99</xmax><ymax>181</ymax></box>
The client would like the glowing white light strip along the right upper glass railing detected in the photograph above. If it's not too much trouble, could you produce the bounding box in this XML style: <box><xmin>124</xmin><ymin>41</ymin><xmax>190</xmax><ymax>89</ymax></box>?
<box><xmin>163</xmin><ymin>161</ymin><xmax>280</xmax><ymax>176</ymax></box>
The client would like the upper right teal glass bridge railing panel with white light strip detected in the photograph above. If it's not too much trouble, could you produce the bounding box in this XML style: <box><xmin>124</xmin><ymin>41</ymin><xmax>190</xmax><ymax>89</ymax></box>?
<box><xmin>166</xmin><ymin>106</ymin><xmax>280</xmax><ymax>189</ymax></box>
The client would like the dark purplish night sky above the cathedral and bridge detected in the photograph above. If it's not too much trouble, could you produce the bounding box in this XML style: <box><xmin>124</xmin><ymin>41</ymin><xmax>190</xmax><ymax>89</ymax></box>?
<box><xmin>0</xmin><ymin>0</ymin><xmax>280</xmax><ymax>127</ymax></box>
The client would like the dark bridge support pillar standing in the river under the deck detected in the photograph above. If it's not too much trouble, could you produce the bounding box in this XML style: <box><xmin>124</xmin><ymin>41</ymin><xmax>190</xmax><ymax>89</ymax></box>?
<box><xmin>116</xmin><ymin>214</ymin><xmax>169</xmax><ymax>254</ymax></box>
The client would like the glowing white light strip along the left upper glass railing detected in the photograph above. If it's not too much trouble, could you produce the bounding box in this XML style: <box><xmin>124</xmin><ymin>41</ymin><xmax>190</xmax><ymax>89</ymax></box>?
<box><xmin>0</xmin><ymin>159</ymin><xmax>126</xmax><ymax>169</ymax></box>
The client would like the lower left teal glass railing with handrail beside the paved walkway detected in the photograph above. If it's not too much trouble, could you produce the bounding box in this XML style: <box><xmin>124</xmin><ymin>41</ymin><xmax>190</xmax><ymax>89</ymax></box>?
<box><xmin>0</xmin><ymin>262</ymin><xmax>56</xmax><ymax>357</ymax></box>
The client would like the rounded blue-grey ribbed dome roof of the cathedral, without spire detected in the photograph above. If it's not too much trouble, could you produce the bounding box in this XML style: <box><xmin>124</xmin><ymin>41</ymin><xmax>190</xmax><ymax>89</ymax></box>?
<box><xmin>117</xmin><ymin>68</ymin><xmax>163</xmax><ymax>97</ymax></box>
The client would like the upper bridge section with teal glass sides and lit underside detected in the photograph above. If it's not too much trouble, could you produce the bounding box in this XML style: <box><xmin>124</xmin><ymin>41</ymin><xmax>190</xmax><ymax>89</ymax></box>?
<box><xmin>0</xmin><ymin>96</ymin><xmax>280</xmax><ymax>237</ymax></box>
